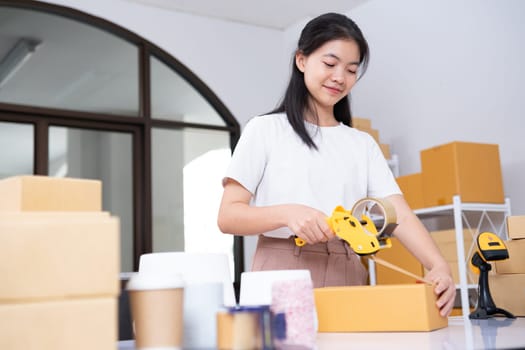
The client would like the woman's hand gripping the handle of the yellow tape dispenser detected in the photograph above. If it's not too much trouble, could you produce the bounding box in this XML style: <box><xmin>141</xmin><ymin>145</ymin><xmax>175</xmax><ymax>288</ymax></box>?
<box><xmin>285</xmin><ymin>204</ymin><xmax>334</xmax><ymax>244</ymax></box>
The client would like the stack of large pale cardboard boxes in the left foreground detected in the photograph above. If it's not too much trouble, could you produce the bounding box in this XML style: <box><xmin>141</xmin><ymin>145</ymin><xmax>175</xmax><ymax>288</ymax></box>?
<box><xmin>0</xmin><ymin>176</ymin><xmax>120</xmax><ymax>350</ymax></box>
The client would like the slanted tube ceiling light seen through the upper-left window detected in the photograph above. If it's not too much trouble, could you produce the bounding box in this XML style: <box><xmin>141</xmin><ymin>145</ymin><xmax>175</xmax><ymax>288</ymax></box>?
<box><xmin>0</xmin><ymin>38</ymin><xmax>41</xmax><ymax>89</ymax></box>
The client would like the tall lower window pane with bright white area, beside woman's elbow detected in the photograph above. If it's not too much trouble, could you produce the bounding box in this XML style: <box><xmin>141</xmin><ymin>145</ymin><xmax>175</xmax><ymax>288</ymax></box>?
<box><xmin>152</xmin><ymin>128</ymin><xmax>234</xmax><ymax>273</ymax></box>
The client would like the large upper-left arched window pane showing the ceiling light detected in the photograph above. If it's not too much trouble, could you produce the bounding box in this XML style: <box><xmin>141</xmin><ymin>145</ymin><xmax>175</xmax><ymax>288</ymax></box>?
<box><xmin>0</xmin><ymin>7</ymin><xmax>139</xmax><ymax>116</ymax></box>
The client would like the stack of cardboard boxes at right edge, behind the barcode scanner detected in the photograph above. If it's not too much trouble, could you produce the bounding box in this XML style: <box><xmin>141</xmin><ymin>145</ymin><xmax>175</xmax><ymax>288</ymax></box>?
<box><xmin>489</xmin><ymin>216</ymin><xmax>525</xmax><ymax>316</ymax></box>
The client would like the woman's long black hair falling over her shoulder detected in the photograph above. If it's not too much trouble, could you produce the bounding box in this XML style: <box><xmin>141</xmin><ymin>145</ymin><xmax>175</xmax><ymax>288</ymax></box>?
<box><xmin>271</xmin><ymin>13</ymin><xmax>369</xmax><ymax>149</ymax></box>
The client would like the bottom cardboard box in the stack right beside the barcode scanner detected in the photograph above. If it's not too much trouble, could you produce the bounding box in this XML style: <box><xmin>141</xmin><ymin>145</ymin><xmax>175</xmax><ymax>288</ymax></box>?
<box><xmin>489</xmin><ymin>273</ymin><xmax>525</xmax><ymax>317</ymax></box>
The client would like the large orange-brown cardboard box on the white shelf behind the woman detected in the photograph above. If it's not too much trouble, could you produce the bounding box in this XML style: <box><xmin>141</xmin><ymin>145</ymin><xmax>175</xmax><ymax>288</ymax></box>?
<box><xmin>420</xmin><ymin>141</ymin><xmax>505</xmax><ymax>207</ymax></box>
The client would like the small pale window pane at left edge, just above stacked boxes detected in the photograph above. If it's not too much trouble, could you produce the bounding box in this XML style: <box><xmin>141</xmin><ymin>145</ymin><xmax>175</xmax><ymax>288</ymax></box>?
<box><xmin>0</xmin><ymin>122</ymin><xmax>34</xmax><ymax>178</ymax></box>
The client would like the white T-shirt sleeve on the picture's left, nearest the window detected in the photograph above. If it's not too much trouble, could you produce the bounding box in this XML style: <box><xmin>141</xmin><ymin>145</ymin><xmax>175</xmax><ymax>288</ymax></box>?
<box><xmin>222</xmin><ymin>117</ymin><xmax>271</xmax><ymax>194</ymax></box>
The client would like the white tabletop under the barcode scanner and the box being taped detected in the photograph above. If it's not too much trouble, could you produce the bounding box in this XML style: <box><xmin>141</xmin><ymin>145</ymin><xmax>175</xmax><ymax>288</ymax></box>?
<box><xmin>118</xmin><ymin>316</ymin><xmax>525</xmax><ymax>350</ymax></box>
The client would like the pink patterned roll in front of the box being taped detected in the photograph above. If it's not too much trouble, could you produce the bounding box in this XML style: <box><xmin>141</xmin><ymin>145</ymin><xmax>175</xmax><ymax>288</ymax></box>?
<box><xmin>271</xmin><ymin>279</ymin><xmax>317</xmax><ymax>349</ymax></box>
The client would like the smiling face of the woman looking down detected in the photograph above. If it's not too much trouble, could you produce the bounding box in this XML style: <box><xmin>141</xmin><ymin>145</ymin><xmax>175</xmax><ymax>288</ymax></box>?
<box><xmin>295</xmin><ymin>39</ymin><xmax>359</xmax><ymax>113</ymax></box>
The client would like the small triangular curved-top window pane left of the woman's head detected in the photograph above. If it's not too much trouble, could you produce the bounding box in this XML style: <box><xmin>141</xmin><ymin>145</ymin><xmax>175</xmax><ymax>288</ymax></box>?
<box><xmin>150</xmin><ymin>57</ymin><xmax>226</xmax><ymax>126</ymax></box>
